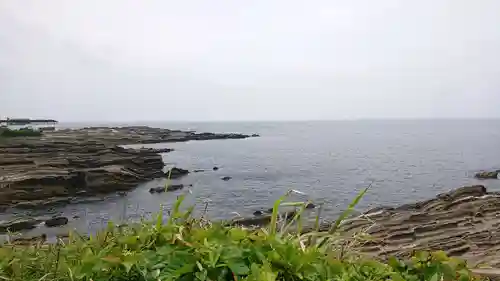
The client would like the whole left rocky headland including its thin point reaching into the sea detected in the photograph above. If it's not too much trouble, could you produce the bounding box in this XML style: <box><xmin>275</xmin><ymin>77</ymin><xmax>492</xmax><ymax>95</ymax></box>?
<box><xmin>0</xmin><ymin>126</ymin><xmax>257</xmax><ymax>209</ymax></box>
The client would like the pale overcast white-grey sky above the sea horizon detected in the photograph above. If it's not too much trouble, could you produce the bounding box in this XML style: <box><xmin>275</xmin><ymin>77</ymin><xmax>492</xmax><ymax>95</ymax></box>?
<box><xmin>0</xmin><ymin>0</ymin><xmax>500</xmax><ymax>121</ymax></box>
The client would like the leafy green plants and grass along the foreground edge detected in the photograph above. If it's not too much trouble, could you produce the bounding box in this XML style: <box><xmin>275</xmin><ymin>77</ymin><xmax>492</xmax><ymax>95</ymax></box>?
<box><xmin>0</xmin><ymin>192</ymin><xmax>480</xmax><ymax>281</ymax></box>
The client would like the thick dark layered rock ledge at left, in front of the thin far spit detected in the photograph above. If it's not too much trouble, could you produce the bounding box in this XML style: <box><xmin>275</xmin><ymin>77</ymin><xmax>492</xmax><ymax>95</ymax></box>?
<box><xmin>0</xmin><ymin>140</ymin><xmax>164</xmax><ymax>207</ymax></box>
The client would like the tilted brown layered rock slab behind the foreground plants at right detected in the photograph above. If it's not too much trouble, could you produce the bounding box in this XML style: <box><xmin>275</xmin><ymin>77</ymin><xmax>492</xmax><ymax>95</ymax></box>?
<box><xmin>322</xmin><ymin>185</ymin><xmax>500</xmax><ymax>267</ymax></box>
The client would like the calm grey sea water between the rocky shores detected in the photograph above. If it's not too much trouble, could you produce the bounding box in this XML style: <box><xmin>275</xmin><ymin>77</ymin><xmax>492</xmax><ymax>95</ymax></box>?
<box><xmin>4</xmin><ymin>120</ymin><xmax>500</xmax><ymax>235</ymax></box>
